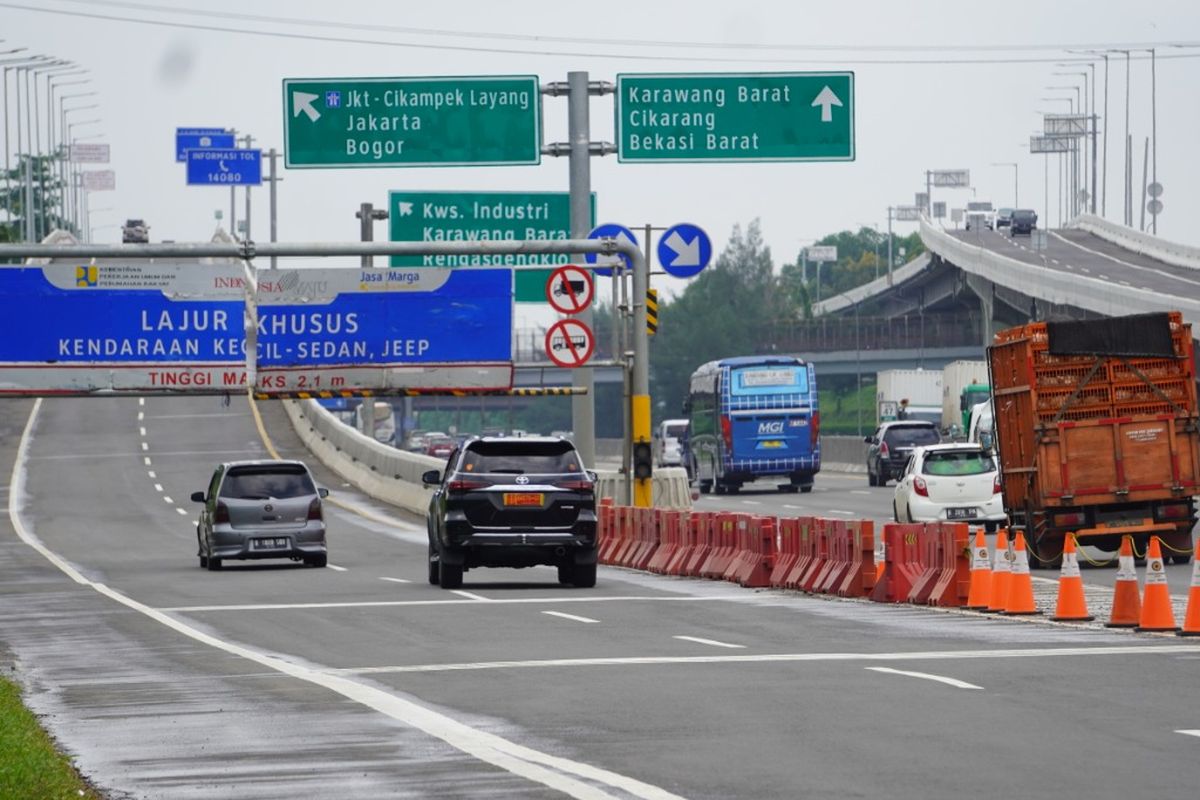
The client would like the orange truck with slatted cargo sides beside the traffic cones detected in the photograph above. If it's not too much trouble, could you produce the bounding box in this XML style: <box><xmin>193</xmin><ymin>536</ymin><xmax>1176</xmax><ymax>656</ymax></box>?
<box><xmin>988</xmin><ymin>312</ymin><xmax>1200</xmax><ymax>566</ymax></box>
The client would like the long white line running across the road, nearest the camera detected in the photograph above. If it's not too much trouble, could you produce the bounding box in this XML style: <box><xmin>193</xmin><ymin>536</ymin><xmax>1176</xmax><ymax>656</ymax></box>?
<box><xmin>330</xmin><ymin>644</ymin><xmax>1200</xmax><ymax>675</ymax></box>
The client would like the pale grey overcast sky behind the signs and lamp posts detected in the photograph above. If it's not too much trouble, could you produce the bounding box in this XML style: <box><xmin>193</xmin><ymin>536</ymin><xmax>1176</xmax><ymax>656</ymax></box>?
<box><xmin>0</xmin><ymin>0</ymin><xmax>1200</xmax><ymax>291</ymax></box>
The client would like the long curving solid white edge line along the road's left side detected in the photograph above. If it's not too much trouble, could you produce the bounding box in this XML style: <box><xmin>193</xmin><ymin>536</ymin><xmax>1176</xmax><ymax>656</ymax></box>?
<box><xmin>8</xmin><ymin>398</ymin><xmax>684</xmax><ymax>800</ymax></box>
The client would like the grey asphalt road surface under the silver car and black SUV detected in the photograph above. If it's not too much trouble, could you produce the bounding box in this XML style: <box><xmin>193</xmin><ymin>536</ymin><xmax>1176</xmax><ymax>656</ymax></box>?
<box><xmin>0</xmin><ymin>397</ymin><xmax>1200</xmax><ymax>799</ymax></box>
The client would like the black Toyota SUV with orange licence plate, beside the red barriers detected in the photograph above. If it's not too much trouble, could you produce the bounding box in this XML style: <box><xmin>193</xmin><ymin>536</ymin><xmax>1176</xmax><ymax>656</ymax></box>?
<box><xmin>421</xmin><ymin>437</ymin><xmax>596</xmax><ymax>589</ymax></box>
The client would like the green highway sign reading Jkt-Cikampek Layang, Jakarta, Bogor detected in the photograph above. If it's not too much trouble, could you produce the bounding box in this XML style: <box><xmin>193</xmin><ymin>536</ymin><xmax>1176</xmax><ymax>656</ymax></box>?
<box><xmin>283</xmin><ymin>76</ymin><xmax>541</xmax><ymax>168</ymax></box>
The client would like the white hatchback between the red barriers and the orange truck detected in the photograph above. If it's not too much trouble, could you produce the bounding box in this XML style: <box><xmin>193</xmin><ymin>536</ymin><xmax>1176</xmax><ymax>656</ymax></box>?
<box><xmin>892</xmin><ymin>443</ymin><xmax>1006</xmax><ymax>531</ymax></box>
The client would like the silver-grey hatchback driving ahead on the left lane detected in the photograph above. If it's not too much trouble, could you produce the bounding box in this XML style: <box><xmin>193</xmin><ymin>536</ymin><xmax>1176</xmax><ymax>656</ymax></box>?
<box><xmin>192</xmin><ymin>461</ymin><xmax>329</xmax><ymax>570</ymax></box>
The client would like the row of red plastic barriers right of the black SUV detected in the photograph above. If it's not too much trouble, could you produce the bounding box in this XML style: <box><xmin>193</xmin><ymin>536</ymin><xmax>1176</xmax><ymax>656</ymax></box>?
<box><xmin>600</xmin><ymin>499</ymin><xmax>972</xmax><ymax>607</ymax></box>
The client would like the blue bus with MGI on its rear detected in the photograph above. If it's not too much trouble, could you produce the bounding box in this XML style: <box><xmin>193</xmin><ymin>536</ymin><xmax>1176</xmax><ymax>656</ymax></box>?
<box><xmin>684</xmin><ymin>356</ymin><xmax>821</xmax><ymax>494</ymax></box>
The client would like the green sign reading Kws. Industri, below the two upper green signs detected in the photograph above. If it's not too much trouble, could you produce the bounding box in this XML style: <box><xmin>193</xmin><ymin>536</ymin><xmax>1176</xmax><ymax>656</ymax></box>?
<box><xmin>388</xmin><ymin>191</ymin><xmax>596</xmax><ymax>302</ymax></box>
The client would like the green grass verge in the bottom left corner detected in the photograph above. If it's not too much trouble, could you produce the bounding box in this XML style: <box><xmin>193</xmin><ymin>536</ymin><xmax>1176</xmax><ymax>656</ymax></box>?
<box><xmin>0</xmin><ymin>676</ymin><xmax>104</xmax><ymax>800</ymax></box>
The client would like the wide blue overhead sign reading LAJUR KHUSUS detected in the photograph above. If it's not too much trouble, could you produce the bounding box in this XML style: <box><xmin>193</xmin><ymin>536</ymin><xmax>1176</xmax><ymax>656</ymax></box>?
<box><xmin>0</xmin><ymin>264</ymin><xmax>512</xmax><ymax>396</ymax></box>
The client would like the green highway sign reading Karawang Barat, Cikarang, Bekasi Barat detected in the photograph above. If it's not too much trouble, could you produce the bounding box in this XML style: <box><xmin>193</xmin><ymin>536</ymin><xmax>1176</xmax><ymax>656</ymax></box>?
<box><xmin>616</xmin><ymin>72</ymin><xmax>854</xmax><ymax>163</ymax></box>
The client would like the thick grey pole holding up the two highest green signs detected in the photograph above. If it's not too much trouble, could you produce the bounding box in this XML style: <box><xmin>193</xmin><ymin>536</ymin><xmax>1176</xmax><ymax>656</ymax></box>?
<box><xmin>566</xmin><ymin>72</ymin><xmax>596</xmax><ymax>468</ymax></box>
